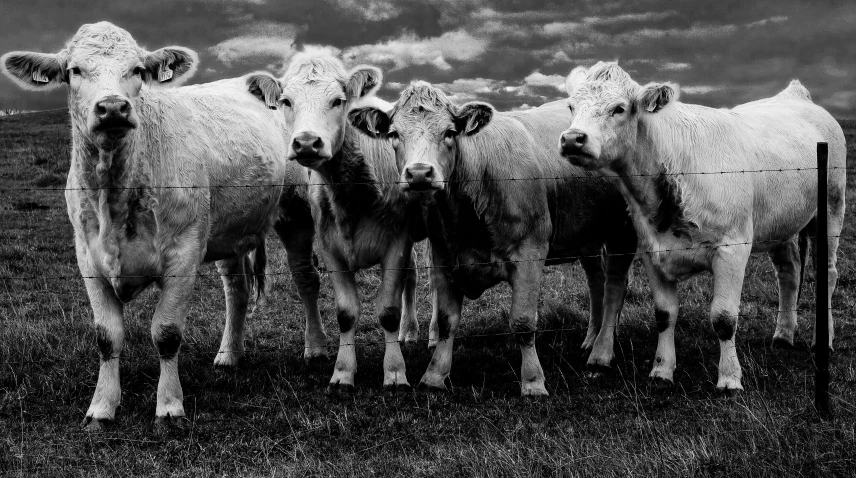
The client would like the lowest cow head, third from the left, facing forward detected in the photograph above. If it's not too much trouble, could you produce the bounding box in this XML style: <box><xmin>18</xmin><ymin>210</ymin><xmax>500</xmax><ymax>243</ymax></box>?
<box><xmin>349</xmin><ymin>81</ymin><xmax>494</xmax><ymax>193</ymax></box>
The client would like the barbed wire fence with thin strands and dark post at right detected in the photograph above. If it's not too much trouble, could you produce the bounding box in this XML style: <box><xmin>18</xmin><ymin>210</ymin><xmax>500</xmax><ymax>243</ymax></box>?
<box><xmin>0</xmin><ymin>145</ymin><xmax>844</xmax><ymax>466</ymax></box>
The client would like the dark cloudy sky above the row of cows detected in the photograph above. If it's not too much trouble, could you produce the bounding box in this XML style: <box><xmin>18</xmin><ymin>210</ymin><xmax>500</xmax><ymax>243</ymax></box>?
<box><xmin>0</xmin><ymin>0</ymin><xmax>856</xmax><ymax>118</ymax></box>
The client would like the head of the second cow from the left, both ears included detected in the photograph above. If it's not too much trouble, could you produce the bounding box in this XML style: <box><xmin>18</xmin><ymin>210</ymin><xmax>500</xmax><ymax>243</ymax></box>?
<box><xmin>248</xmin><ymin>51</ymin><xmax>382</xmax><ymax>169</ymax></box>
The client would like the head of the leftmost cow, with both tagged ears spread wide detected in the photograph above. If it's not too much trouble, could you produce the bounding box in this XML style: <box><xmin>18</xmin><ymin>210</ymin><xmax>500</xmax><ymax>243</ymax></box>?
<box><xmin>0</xmin><ymin>22</ymin><xmax>197</xmax><ymax>148</ymax></box>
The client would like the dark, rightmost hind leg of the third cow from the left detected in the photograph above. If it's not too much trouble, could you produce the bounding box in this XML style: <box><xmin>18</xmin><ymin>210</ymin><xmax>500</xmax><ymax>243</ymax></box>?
<box><xmin>588</xmin><ymin>246</ymin><xmax>635</xmax><ymax>368</ymax></box>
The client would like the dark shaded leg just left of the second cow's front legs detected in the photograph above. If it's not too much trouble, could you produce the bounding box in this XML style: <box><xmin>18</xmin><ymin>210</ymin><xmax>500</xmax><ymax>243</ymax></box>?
<box><xmin>274</xmin><ymin>217</ymin><xmax>327</xmax><ymax>363</ymax></box>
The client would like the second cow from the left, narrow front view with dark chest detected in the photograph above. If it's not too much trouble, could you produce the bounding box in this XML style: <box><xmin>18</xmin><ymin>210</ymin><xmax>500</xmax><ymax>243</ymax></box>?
<box><xmin>244</xmin><ymin>52</ymin><xmax>424</xmax><ymax>393</ymax></box>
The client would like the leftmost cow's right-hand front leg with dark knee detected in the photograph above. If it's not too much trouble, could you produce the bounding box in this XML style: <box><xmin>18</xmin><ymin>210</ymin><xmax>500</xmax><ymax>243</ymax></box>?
<box><xmin>151</xmin><ymin>267</ymin><xmax>196</xmax><ymax>425</ymax></box>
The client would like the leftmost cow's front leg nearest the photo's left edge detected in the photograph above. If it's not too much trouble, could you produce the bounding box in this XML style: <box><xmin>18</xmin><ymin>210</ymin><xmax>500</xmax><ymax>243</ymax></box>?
<box><xmin>78</xmin><ymin>270</ymin><xmax>125</xmax><ymax>431</ymax></box>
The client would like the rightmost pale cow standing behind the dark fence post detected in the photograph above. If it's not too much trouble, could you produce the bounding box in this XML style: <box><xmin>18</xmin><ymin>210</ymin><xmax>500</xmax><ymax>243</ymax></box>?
<box><xmin>560</xmin><ymin>62</ymin><xmax>846</xmax><ymax>390</ymax></box>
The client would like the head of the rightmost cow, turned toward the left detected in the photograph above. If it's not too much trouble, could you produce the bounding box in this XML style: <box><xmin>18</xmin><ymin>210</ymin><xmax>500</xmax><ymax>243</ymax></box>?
<box><xmin>559</xmin><ymin>62</ymin><xmax>678</xmax><ymax>169</ymax></box>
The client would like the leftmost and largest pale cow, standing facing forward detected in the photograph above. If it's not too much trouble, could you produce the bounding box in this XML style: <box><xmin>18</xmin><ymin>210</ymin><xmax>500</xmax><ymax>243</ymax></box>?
<box><xmin>0</xmin><ymin>22</ymin><xmax>323</xmax><ymax>430</ymax></box>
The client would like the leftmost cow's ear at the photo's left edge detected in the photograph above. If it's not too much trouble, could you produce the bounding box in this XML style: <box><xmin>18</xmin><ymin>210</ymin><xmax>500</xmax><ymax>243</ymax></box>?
<box><xmin>0</xmin><ymin>51</ymin><xmax>65</xmax><ymax>91</ymax></box>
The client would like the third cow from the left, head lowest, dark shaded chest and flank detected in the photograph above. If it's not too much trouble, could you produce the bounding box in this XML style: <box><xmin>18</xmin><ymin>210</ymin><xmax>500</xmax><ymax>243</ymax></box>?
<box><xmin>350</xmin><ymin>82</ymin><xmax>636</xmax><ymax>395</ymax></box>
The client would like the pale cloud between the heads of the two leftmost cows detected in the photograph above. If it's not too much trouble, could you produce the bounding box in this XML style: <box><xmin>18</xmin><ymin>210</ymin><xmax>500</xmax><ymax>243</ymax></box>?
<box><xmin>208</xmin><ymin>22</ymin><xmax>301</xmax><ymax>67</ymax></box>
